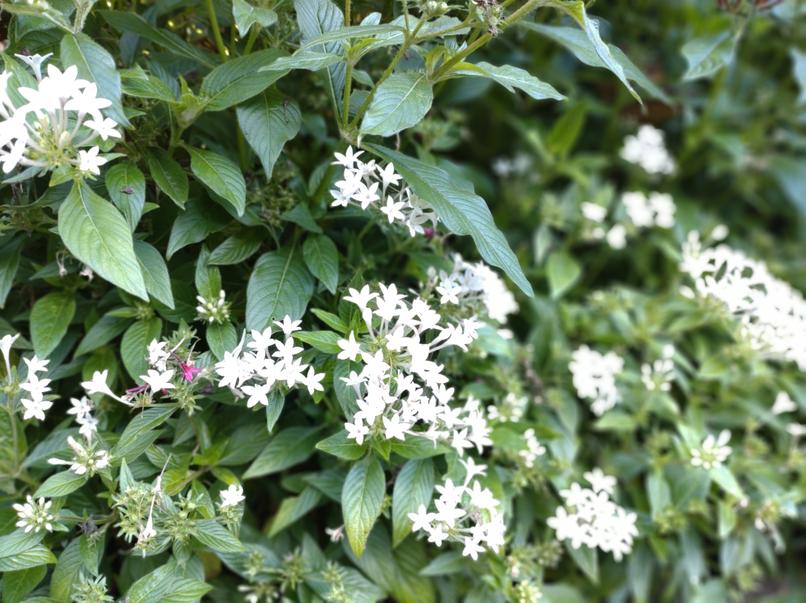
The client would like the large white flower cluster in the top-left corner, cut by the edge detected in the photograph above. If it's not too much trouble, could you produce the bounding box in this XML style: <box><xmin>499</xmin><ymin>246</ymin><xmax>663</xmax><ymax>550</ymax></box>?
<box><xmin>0</xmin><ymin>55</ymin><xmax>121</xmax><ymax>175</ymax></box>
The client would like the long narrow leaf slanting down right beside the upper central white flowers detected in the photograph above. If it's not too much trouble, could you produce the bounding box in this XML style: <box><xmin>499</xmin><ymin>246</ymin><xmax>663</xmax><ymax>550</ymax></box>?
<box><xmin>366</xmin><ymin>145</ymin><xmax>534</xmax><ymax>296</ymax></box>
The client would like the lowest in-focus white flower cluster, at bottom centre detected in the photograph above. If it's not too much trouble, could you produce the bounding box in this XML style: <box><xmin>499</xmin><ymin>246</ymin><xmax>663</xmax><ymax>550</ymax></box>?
<box><xmin>408</xmin><ymin>459</ymin><xmax>506</xmax><ymax>560</ymax></box>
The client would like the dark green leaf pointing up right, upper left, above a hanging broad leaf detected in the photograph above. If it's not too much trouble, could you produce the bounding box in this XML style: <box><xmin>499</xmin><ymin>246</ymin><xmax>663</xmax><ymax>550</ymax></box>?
<box><xmin>200</xmin><ymin>48</ymin><xmax>285</xmax><ymax>111</ymax></box>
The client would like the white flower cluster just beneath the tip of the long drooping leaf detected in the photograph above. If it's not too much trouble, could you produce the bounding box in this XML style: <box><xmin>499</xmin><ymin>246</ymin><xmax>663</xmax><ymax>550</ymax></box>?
<box><xmin>428</xmin><ymin>253</ymin><xmax>518</xmax><ymax>323</ymax></box>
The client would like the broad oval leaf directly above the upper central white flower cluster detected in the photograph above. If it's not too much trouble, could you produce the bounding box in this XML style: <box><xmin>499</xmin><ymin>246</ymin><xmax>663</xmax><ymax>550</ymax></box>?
<box><xmin>361</xmin><ymin>71</ymin><xmax>434</xmax><ymax>136</ymax></box>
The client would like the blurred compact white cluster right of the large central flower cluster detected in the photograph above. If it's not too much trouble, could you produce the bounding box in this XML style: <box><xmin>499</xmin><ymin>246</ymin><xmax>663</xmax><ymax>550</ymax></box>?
<box><xmin>568</xmin><ymin>345</ymin><xmax>624</xmax><ymax>416</ymax></box>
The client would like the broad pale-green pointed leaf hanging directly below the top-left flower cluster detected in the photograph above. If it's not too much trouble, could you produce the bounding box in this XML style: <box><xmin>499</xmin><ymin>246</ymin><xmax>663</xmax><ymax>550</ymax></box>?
<box><xmin>58</xmin><ymin>183</ymin><xmax>148</xmax><ymax>300</ymax></box>
